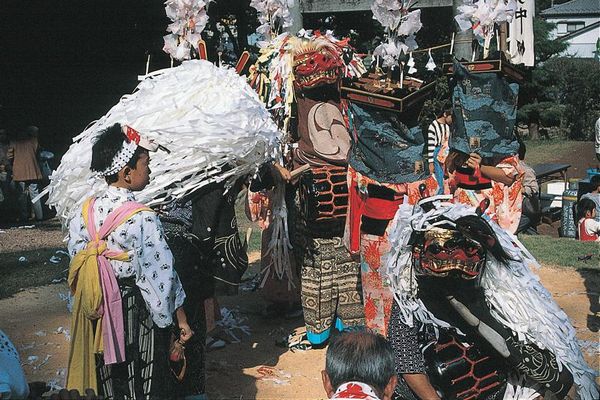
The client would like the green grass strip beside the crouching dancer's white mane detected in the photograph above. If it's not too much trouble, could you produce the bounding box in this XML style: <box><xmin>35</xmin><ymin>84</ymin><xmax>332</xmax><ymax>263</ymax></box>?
<box><xmin>519</xmin><ymin>235</ymin><xmax>600</xmax><ymax>270</ymax></box>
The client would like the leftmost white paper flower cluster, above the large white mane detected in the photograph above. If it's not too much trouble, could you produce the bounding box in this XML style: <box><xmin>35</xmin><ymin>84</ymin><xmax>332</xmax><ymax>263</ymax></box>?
<box><xmin>163</xmin><ymin>0</ymin><xmax>212</xmax><ymax>61</ymax></box>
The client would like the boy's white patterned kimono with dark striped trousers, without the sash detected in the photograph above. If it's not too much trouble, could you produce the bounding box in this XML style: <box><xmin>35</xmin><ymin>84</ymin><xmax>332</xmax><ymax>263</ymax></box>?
<box><xmin>67</xmin><ymin>186</ymin><xmax>185</xmax><ymax>399</ymax></box>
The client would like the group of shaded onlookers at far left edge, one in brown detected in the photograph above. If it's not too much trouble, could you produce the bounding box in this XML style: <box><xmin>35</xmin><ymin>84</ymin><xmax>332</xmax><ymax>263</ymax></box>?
<box><xmin>0</xmin><ymin>126</ymin><xmax>54</xmax><ymax>223</ymax></box>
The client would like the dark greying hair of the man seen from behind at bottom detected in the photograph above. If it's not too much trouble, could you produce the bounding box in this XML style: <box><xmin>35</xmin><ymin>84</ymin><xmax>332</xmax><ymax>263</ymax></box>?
<box><xmin>325</xmin><ymin>332</ymin><xmax>396</xmax><ymax>395</ymax></box>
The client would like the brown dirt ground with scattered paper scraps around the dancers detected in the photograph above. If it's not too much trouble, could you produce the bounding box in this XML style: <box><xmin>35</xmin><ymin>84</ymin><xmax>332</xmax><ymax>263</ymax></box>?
<box><xmin>0</xmin><ymin>254</ymin><xmax>600</xmax><ymax>399</ymax></box>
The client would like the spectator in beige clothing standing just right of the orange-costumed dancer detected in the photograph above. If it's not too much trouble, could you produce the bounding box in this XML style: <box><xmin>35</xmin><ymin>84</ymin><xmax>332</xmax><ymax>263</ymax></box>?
<box><xmin>517</xmin><ymin>138</ymin><xmax>541</xmax><ymax>234</ymax></box>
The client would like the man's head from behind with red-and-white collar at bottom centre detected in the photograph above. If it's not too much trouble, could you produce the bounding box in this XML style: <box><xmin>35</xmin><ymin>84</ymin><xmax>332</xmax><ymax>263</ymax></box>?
<box><xmin>322</xmin><ymin>332</ymin><xmax>398</xmax><ymax>400</ymax></box>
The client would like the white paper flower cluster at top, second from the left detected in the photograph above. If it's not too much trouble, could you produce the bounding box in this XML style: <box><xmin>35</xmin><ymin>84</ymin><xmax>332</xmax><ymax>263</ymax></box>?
<box><xmin>250</xmin><ymin>0</ymin><xmax>294</xmax><ymax>40</ymax></box>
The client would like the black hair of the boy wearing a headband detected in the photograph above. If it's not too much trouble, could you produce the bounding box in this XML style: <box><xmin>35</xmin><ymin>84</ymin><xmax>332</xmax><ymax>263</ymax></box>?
<box><xmin>90</xmin><ymin>124</ymin><xmax>147</xmax><ymax>184</ymax></box>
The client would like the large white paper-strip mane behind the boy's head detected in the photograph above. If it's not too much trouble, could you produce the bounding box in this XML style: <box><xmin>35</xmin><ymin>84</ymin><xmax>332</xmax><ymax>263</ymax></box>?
<box><xmin>48</xmin><ymin>60</ymin><xmax>280</xmax><ymax>222</ymax></box>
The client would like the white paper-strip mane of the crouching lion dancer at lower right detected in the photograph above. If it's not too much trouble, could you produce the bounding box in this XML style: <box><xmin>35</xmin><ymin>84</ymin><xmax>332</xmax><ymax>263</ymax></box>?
<box><xmin>384</xmin><ymin>196</ymin><xmax>598</xmax><ymax>400</ymax></box>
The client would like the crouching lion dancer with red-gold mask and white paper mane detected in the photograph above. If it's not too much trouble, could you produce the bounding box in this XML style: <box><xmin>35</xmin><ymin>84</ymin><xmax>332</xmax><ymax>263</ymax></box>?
<box><xmin>383</xmin><ymin>196</ymin><xmax>598</xmax><ymax>399</ymax></box>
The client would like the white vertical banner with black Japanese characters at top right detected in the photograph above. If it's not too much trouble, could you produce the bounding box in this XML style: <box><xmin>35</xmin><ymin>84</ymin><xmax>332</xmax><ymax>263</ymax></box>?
<box><xmin>508</xmin><ymin>0</ymin><xmax>535</xmax><ymax>67</ymax></box>
